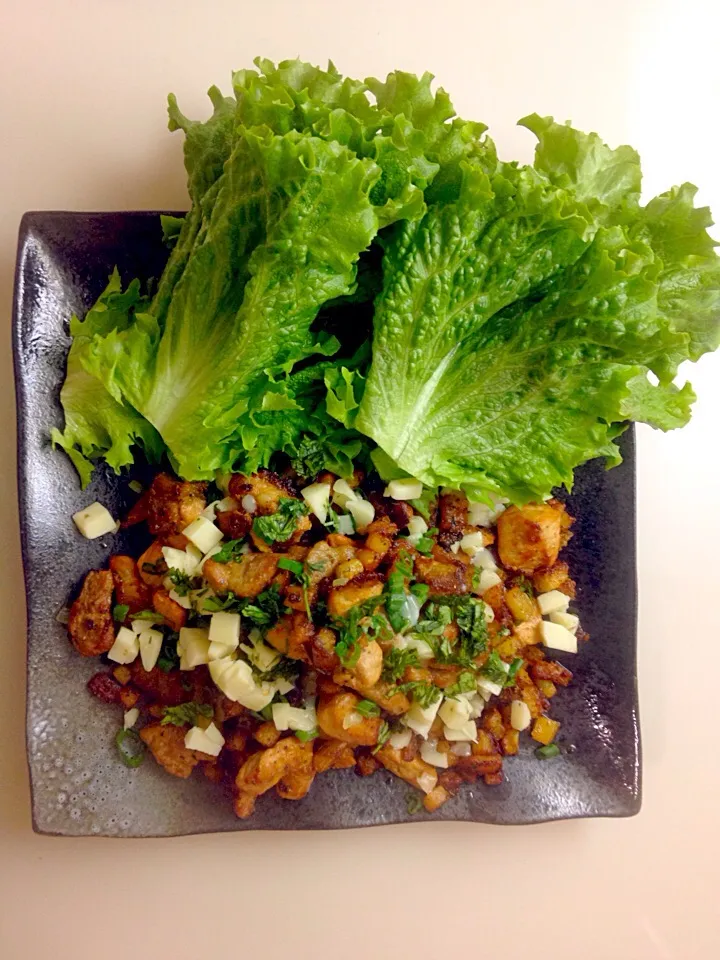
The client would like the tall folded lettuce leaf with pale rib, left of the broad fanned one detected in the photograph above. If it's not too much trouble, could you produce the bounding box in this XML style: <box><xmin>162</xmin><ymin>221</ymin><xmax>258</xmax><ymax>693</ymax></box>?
<box><xmin>86</xmin><ymin>129</ymin><xmax>379</xmax><ymax>479</ymax></box>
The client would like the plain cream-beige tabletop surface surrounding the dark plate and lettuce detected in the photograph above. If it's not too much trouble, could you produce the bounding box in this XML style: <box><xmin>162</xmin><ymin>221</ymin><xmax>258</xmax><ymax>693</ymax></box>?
<box><xmin>0</xmin><ymin>0</ymin><xmax>720</xmax><ymax>960</ymax></box>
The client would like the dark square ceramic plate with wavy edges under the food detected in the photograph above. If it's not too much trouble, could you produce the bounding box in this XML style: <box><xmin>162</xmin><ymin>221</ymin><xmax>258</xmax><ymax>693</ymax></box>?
<box><xmin>14</xmin><ymin>213</ymin><xmax>640</xmax><ymax>837</ymax></box>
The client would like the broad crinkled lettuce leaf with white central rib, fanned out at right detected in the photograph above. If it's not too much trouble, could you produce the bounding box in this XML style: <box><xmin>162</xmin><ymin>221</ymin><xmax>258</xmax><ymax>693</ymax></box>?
<box><xmin>356</xmin><ymin>128</ymin><xmax>717</xmax><ymax>502</ymax></box>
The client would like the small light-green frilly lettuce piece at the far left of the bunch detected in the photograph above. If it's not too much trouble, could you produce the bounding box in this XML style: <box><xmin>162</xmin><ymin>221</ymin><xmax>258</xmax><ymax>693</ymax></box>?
<box><xmin>51</xmin><ymin>270</ymin><xmax>164</xmax><ymax>487</ymax></box>
